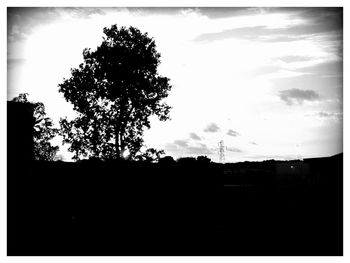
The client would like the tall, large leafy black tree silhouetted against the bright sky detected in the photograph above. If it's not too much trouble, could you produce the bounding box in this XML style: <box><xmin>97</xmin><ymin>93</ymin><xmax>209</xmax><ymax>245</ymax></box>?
<box><xmin>59</xmin><ymin>25</ymin><xmax>171</xmax><ymax>159</ymax></box>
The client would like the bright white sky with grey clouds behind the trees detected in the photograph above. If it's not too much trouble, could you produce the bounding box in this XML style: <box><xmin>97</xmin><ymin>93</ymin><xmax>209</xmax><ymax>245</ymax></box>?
<box><xmin>7</xmin><ymin>8</ymin><xmax>343</xmax><ymax>162</ymax></box>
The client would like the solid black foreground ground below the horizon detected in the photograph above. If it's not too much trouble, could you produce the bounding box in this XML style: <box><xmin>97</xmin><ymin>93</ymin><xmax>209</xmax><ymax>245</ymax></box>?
<box><xmin>7</xmin><ymin>154</ymin><xmax>343</xmax><ymax>256</ymax></box>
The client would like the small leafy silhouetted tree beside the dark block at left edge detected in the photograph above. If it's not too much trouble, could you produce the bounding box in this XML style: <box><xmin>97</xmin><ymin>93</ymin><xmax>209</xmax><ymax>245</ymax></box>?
<box><xmin>12</xmin><ymin>93</ymin><xmax>59</xmax><ymax>161</ymax></box>
